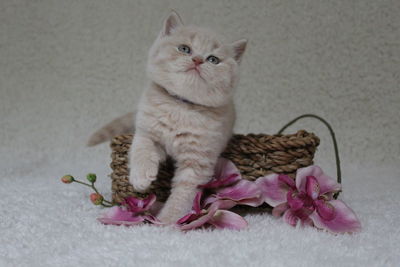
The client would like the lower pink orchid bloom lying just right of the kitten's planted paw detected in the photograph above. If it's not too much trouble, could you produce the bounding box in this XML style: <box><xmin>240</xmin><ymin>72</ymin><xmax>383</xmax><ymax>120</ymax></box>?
<box><xmin>177</xmin><ymin>191</ymin><xmax>247</xmax><ymax>231</ymax></box>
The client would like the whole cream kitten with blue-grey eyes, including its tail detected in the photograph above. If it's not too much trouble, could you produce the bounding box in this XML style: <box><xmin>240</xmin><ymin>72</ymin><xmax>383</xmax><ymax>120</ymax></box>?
<box><xmin>89</xmin><ymin>12</ymin><xmax>247</xmax><ymax>223</ymax></box>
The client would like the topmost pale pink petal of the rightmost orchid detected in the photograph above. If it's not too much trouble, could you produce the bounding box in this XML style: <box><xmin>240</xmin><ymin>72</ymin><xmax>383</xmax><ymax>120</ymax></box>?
<box><xmin>296</xmin><ymin>165</ymin><xmax>342</xmax><ymax>195</ymax></box>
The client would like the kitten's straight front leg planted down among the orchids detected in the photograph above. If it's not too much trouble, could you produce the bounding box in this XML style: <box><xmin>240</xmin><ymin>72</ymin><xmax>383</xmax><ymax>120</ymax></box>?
<box><xmin>157</xmin><ymin>162</ymin><xmax>214</xmax><ymax>224</ymax></box>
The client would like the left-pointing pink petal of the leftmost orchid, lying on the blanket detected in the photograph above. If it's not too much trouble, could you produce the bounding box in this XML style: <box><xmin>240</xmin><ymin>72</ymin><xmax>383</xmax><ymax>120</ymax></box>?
<box><xmin>98</xmin><ymin>206</ymin><xmax>144</xmax><ymax>225</ymax></box>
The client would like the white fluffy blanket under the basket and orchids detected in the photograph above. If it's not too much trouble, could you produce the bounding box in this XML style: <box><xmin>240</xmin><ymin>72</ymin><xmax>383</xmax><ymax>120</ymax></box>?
<box><xmin>0</xmin><ymin>162</ymin><xmax>400</xmax><ymax>266</ymax></box>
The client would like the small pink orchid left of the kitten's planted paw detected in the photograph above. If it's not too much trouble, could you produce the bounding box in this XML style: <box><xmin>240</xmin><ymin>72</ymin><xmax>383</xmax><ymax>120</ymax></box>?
<box><xmin>98</xmin><ymin>194</ymin><xmax>161</xmax><ymax>226</ymax></box>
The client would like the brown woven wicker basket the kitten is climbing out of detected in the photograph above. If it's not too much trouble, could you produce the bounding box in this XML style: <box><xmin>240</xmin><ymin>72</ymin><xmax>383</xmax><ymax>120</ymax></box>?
<box><xmin>110</xmin><ymin>130</ymin><xmax>319</xmax><ymax>203</ymax></box>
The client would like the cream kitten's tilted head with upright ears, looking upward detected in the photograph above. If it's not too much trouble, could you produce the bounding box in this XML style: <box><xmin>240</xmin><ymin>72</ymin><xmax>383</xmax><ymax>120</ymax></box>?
<box><xmin>147</xmin><ymin>12</ymin><xmax>247</xmax><ymax>107</ymax></box>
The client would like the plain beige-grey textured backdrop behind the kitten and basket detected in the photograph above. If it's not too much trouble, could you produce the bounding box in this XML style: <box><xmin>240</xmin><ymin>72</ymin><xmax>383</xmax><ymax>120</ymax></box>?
<box><xmin>0</xmin><ymin>0</ymin><xmax>400</xmax><ymax>178</ymax></box>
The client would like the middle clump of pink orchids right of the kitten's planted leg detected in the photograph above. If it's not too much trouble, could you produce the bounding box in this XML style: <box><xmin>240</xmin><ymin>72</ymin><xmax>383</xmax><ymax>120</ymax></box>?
<box><xmin>177</xmin><ymin>158</ymin><xmax>264</xmax><ymax>230</ymax></box>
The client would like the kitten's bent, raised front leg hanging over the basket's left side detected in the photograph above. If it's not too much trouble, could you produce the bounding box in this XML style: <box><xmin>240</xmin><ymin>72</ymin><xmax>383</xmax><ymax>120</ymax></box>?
<box><xmin>129</xmin><ymin>134</ymin><xmax>165</xmax><ymax>192</ymax></box>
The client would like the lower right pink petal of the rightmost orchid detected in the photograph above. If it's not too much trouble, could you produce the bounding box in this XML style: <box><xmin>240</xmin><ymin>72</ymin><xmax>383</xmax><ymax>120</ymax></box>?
<box><xmin>310</xmin><ymin>200</ymin><xmax>361</xmax><ymax>233</ymax></box>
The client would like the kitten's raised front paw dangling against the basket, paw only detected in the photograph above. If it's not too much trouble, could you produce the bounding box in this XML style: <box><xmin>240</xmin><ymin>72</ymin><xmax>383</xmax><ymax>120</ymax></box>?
<box><xmin>129</xmin><ymin>157</ymin><xmax>158</xmax><ymax>192</ymax></box>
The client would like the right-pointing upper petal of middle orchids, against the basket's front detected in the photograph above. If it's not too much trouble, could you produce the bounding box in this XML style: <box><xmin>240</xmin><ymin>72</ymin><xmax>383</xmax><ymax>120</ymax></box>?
<box><xmin>217</xmin><ymin>180</ymin><xmax>264</xmax><ymax>207</ymax></box>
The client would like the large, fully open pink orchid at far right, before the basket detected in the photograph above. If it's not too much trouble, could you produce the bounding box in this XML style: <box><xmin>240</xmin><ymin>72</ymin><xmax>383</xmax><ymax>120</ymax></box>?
<box><xmin>256</xmin><ymin>166</ymin><xmax>361</xmax><ymax>233</ymax></box>
